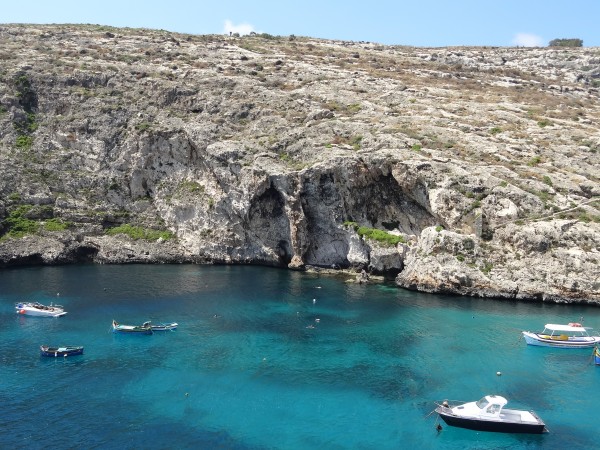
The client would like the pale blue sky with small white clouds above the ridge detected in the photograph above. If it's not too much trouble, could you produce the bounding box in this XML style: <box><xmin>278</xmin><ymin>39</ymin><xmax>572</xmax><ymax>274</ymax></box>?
<box><xmin>0</xmin><ymin>0</ymin><xmax>600</xmax><ymax>47</ymax></box>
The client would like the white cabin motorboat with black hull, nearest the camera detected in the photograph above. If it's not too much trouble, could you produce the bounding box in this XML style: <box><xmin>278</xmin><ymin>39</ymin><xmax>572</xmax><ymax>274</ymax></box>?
<box><xmin>435</xmin><ymin>395</ymin><xmax>548</xmax><ymax>433</ymax></box>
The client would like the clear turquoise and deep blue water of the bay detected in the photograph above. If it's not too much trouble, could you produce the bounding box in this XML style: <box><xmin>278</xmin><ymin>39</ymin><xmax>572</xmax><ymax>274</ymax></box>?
<box><xmin>0</xmin><ymin>265</ymin><xmax>600</xmax><ymax>449</ymax></box>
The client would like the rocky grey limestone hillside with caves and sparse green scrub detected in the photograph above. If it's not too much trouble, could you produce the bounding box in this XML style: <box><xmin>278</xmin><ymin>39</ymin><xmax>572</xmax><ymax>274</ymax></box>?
<box><xmin>0</xmin><ymin>25</ymin><xmax>600</xmax><ymax>303</ymax></box>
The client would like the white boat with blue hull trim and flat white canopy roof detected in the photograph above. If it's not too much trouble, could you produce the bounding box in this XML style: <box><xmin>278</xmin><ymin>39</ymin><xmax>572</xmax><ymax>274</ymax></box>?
<box><xmin>523</xmin><ymin>323</ymin><xmax>600</xmax><ymax>348</ymax></box>
